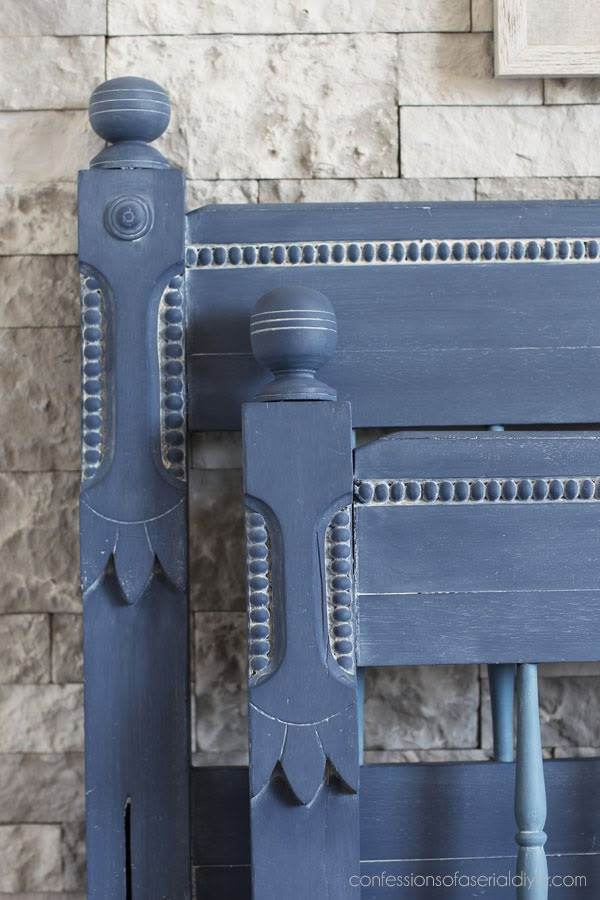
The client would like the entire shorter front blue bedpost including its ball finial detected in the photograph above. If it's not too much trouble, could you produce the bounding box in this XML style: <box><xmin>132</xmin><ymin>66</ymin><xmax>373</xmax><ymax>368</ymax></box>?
<box><xmin>243</xmin><ymin>287</ymin><xmax>360</xmax><ymax>900</ymax></box>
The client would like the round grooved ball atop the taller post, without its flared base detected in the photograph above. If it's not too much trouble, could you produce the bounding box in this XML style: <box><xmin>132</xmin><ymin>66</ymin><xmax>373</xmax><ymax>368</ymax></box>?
<box><xmin>89</xmin><ymin>76</ymin><xmax>171</xmax><ymax>144</ymax></box>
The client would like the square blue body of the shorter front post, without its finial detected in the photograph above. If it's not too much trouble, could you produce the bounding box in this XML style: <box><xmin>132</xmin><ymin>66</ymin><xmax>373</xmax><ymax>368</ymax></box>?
<box><xmin>243</xmin><ymin>401</ymin><xmax>359</xmax><ymax>900</ymax></box>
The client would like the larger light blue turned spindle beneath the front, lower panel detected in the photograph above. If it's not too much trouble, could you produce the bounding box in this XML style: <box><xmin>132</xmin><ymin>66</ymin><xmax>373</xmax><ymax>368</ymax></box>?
<box><xmin>515</xmin><ymin>663</ymin><xmax>548</xmax><ymax>900</ymax></box>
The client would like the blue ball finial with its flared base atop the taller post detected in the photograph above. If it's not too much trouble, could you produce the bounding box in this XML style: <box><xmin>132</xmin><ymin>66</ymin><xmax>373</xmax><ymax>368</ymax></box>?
<box><xmin>89</xmin><ymin>76</ymin><xmax>171</xmax><ymax>168</ymax></box>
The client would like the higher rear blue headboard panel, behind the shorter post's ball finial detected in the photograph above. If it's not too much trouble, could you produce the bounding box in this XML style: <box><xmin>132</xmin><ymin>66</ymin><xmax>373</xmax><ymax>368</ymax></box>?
<box><xmin>186</xmin><ymin>201</ymin><xmax>600</xmax><ymax>431</ymax></box>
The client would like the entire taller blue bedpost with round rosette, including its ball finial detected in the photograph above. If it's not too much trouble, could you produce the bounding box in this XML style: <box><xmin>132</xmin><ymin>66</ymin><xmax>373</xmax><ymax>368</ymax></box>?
<box><xmin>79</xmin><ymin>78</ymin><xmax>191</xmax><ymax>900</ymax></box>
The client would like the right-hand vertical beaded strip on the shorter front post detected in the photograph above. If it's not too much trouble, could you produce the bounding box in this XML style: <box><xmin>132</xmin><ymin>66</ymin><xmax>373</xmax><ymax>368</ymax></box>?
<box><xmin>325</xmin><ymin>506</ymin><xmax>354</xmax><ymax>672</ymax></box>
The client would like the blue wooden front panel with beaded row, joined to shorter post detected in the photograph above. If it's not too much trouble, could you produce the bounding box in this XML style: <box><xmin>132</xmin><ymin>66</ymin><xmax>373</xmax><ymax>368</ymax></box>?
<box><xmin>355</xmin><ymin>432</ymin><xmax>600</xmax><ymax>665</ymax></box>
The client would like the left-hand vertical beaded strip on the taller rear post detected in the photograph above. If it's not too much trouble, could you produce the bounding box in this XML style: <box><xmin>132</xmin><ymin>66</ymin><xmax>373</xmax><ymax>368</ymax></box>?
<box><xmin>81</xmin><ymin>275</ymin><xmax>106</xmax><ymax>481</ymax></box>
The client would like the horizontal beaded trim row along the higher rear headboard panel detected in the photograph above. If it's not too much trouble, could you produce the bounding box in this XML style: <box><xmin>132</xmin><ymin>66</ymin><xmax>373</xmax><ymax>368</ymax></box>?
<box><xmin>186</xmin><ymin>238</ymin><xmax>600</xmax><ymax>269</ymax></box>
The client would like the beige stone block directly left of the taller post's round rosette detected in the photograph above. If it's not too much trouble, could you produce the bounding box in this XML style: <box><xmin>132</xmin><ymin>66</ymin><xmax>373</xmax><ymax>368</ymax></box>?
<box><xmin>0</xmin><ymin>182</ymin><xmax>77</xmax><ymax>256</ymax></box>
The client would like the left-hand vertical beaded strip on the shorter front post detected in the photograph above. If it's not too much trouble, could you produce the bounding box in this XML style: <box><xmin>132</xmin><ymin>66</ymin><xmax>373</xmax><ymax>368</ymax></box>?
<box><xmin>246</xmin><ymin>511</ymin><xmax>273</xmax><ymax>677</ymax></box>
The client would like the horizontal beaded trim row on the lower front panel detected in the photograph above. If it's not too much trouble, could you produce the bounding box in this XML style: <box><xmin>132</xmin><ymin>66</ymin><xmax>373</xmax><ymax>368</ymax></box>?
<box><xmin>354</xmin><ymin>477</ymin><xmax>600</xmax><ymax>506</ymax></box>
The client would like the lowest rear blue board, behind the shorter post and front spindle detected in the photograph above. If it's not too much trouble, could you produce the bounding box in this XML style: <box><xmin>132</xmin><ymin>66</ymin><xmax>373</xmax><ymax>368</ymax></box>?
<box><xmin>192</xmin><ymin>759</ymin><xmax>600</xmax><ymax>900</ymax></box>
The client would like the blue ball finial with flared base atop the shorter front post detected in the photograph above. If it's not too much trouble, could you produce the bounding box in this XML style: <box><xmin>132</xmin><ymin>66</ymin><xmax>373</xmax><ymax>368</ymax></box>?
<box><xmin>250</xmin><ymin>285</ymin><xmax>337</xmax><ymax>400</ymax></box>
